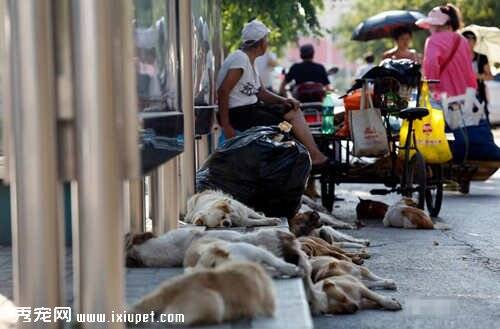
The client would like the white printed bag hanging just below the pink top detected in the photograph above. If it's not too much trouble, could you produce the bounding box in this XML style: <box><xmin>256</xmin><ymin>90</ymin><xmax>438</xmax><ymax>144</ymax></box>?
<box><xmin>441</xmin><ymin>88</ymin><xmax>484</xmax><ymax>130</ymax></box>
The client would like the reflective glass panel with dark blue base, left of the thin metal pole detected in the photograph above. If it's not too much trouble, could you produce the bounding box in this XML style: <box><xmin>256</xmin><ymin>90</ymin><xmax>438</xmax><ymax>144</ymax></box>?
<box><xmin>134</xmin><ymin>0</ymin><xmax>184</xmax><ymax>172</ymax></box>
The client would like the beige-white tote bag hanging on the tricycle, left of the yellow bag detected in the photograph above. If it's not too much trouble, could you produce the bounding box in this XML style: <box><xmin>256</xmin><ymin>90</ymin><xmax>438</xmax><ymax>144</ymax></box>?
<box><xmin>348</xmin><ymin>86</ymin><xmax>389</xmax><ymax>157</ymax></box>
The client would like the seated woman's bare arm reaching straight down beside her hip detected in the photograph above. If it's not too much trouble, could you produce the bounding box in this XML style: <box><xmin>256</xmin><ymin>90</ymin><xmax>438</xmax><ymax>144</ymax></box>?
<box><xmin>217</xmin><ymin>69</ymin><xmax>243</xmax><ymax>138</ymax></box>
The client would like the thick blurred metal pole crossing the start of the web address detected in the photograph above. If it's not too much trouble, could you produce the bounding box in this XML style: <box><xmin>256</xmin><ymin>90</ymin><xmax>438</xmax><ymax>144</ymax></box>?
<box><xmin>73</xmin><ymin>0</ymin><xmax>127</xmax><ymax>328</ymax></box>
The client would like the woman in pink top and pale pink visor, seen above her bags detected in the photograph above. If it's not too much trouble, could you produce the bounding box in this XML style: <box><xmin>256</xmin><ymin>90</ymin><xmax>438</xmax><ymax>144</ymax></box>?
<box><xmin>416</xmin><ymin>4</ymin><xmax>477</xmax><ymax>100</ymax></box>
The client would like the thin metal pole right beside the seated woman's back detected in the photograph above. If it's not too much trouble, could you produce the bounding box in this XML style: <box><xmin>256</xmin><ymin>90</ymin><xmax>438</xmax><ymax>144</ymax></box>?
<box><xmin>178</xmin><ymin>0</ymin><xmax>196</xmax><ymax>213</ymax></box>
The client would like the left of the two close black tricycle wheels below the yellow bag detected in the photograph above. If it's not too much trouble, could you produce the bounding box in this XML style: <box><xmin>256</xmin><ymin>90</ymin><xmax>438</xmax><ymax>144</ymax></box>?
<box><xmin>401</xmin><ymin>152</ymin><xmax>427</xmax><ymax>209</ymax></box>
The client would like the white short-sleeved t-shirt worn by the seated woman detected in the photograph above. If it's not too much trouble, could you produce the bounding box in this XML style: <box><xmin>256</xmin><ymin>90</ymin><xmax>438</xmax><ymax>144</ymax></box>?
<box><xmin>217</xmin><ymin>50</ymin><xmax>260</xmax><ymax>108</ymax></box>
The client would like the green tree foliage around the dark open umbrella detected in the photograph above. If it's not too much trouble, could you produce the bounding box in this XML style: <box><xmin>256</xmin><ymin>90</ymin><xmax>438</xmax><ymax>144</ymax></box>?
<box><xmin>334</xmin><ymin>0</ymin><xmax>500</xmax><ymax>59</ymax></box>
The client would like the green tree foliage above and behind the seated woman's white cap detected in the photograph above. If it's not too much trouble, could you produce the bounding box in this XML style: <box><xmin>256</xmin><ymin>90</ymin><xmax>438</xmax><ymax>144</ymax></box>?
<box><xmin>222</xmin><ymin>0</ymin><xmax>323</xmax><ymax>52</ymax></box>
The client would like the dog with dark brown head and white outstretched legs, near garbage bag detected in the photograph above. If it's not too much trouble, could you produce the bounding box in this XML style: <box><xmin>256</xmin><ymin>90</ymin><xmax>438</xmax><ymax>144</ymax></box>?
<box><xmin>288</xmin><ymin>211</ymin><xmax>370</xmax><ymax>248</ymax></box>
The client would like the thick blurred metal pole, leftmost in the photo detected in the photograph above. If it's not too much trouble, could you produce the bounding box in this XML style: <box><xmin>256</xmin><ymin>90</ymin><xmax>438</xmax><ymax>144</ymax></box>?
<box><xmin>3</xmin><ymin>0</ymin><xmax>64</xmax><ymax>328</ymax></box>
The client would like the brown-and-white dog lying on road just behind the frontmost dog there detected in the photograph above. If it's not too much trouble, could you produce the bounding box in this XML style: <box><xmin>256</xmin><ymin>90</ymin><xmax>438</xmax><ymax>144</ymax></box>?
<box><xmin>310</xmin><ymin>256</ymin><xmax>396</xmax><ymax>290</ymax></box>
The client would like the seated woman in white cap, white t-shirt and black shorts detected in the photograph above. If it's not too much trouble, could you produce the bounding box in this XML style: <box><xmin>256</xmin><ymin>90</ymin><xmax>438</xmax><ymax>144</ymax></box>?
<box><xmin>217</xmin><ymin>20</ymin><xmax>328</xmax><ymax>167</ymax></box>
